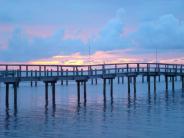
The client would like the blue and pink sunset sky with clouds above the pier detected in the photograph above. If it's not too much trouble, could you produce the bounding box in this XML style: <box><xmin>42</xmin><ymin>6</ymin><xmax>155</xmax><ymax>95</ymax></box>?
<box><xmin>0</xmin><ymin>0</ymin><xmax>184</xmax><ymax>64</ymax></box>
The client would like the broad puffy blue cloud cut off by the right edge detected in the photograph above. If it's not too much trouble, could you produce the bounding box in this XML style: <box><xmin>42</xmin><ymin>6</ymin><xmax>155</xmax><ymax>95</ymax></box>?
<box><xmin>130</xmin><ymin>14</ymin><xmax>184</xmax><ymax>50</ymax></box>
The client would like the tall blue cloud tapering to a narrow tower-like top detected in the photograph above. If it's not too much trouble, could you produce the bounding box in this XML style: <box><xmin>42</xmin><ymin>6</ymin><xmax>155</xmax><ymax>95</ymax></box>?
<box><xmin>93</xmin><ymin>9</ymin><xmax>130</xmax><ymax>51</ymax></box>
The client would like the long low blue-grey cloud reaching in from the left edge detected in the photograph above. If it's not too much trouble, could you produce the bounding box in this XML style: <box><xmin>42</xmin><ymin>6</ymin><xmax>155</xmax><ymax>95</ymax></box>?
<box><xmin>0</xmin><ymin>29</ymin><xmax>87</xmax><ymax>61</ymax></box>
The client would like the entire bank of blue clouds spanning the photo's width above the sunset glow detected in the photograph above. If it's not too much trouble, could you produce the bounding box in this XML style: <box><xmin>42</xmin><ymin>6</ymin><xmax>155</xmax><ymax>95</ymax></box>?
<box><xmin>0</xmin><ymin>9</ymin><xmax>184</xmax><ymax>62</ymax></box>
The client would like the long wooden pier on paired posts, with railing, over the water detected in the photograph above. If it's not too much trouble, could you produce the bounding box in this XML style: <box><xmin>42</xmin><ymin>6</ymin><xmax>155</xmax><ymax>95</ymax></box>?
<box><xmin>0</xmin><ymin>63</ymin><xmax>184</xmax><ymax>108</ymax></box>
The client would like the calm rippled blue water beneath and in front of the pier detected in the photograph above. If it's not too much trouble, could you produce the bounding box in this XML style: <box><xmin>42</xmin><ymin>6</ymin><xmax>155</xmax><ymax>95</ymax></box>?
<box><xmin>0</xmin><ymin>78</ymin><xmax>184</xmax><ymax>138</ymax></box>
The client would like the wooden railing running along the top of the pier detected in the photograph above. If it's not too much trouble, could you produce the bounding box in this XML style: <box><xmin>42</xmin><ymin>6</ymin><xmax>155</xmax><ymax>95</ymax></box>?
<box><xmin>0</xmin><ymin>63</ymin><xmax>184</xmax><ymax>78</ymax></box>
